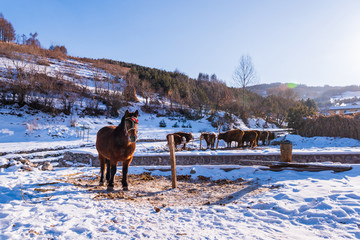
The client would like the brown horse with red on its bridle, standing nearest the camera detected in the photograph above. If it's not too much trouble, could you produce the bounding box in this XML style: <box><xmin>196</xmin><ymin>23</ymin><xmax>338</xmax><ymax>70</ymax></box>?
<box><xmin>96</xmin><ymin>110</ymin><xmax>139</xmax><ymax>191</ymax></box>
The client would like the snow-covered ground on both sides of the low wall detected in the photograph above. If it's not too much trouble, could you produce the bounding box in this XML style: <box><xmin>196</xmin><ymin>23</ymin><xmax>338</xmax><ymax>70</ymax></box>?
<box><xmin>0</xmin><ymin>106</ymin><xmax>360</xmax><ymax>239</ymax></box>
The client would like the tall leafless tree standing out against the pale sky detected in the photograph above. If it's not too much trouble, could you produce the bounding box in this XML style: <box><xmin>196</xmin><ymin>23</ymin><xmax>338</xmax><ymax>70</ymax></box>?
<box><xmin>233</xmin><ymin>55</ymin><xmax>257</xmax><ymax>111</ymax></box>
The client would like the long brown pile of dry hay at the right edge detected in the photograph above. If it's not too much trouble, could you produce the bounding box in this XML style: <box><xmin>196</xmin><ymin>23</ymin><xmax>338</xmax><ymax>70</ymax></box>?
<box><xmin>297</xmin><ymin>113</ymin><xmax>360</xmax><ymax>140</ymax></box>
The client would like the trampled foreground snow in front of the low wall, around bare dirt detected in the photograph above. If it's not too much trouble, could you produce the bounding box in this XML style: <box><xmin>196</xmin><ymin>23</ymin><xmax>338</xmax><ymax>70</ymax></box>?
<box><xmin>0</xmin><ymin>162</ymin><xmax>360</xmax><ymax>239</ymax></box>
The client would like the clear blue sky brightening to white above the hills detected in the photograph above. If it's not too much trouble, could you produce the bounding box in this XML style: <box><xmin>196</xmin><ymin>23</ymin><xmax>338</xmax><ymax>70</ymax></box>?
<box><xmin>0</xmin><ymin>0</ymin><xmax>360</xmax><ymax>86</ymax></box>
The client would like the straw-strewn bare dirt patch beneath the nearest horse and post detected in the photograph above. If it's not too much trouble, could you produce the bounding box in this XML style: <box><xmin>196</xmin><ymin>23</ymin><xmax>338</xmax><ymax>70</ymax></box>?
<box><xmin>65</xmin><ymin>172</ymin><xmax>268</xmax><ymax>206</ymax></box>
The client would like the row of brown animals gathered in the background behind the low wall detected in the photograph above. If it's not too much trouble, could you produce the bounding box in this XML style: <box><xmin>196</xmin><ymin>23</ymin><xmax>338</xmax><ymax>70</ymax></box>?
<box><xmin>166</xmin><ymin>129</ymin><xmax>275</xmax><ymax>150</ymax></box>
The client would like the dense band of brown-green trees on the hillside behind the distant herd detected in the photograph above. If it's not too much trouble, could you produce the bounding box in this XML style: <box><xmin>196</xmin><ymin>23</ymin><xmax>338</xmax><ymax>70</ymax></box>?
<box><xmin>92</xmin><ymin>59</ymin><xmax>317</xmax><ymax>125</ymax></box>
